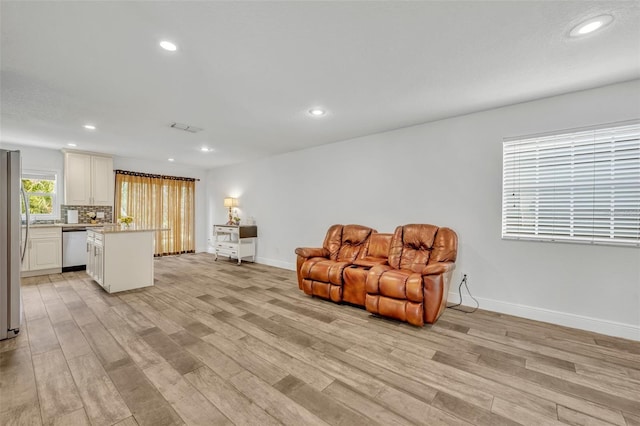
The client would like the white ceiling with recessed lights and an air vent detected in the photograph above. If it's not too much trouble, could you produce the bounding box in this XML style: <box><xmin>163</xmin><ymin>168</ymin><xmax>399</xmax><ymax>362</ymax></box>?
<box><xmin>0</xmin><ymin>0</ymin><xmax>640</xmax><ymax>168</ymax></box>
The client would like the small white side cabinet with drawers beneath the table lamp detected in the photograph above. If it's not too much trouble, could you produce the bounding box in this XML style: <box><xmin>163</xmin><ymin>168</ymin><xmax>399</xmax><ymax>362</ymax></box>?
<box><xmin>213</xmin><ymin>225</ymin><xmax>258</xmax><ymax>264</ymax></box>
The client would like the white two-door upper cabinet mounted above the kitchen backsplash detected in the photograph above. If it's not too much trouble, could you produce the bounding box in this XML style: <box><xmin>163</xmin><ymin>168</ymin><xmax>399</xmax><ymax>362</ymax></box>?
<box><xmin>64</xmin><ymin>151</ymin><xmax>113</xmax><ymax>206</ymax></box>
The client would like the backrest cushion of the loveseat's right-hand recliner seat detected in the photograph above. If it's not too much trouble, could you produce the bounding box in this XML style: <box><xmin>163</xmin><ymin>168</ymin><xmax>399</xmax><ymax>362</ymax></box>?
<box><xmin>389</xmin><ymin>224</ymin><xmax>438</xmax><ymax>272</ymax></box>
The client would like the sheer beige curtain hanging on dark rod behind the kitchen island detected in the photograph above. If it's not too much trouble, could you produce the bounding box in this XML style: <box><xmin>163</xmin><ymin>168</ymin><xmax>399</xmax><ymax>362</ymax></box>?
<box><xmin>115</xmin><ymin>170</ymin><xmax>195</xmax><ymax>256</ymax></box>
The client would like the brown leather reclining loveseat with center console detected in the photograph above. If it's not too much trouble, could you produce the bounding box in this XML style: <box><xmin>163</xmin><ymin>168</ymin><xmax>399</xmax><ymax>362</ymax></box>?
<box><xmin>296</xmin><ymin>225</ymin><xmax>458</xmax><ymax>326</ymax></box>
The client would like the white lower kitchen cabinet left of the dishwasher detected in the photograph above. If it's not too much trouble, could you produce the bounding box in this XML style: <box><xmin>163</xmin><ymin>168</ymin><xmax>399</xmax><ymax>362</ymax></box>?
<box><xmin>22</xmin><ymin>226</ymin><xmax>62</xmax><ymax>277</ymax></box>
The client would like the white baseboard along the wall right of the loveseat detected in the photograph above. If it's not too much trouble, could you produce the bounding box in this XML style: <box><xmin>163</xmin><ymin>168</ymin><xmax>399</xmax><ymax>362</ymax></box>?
<box><xmin>448</xmin><ymin>292</ymin><xmax>640</xmax><ymax>341</ymax></box>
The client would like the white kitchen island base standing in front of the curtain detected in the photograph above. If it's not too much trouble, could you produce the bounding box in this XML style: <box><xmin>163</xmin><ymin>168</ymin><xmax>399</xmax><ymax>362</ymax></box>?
<box><xmin>87</xmin><ymin>228</ymin><xmax>156</xmax><ymax>293</ymax></box>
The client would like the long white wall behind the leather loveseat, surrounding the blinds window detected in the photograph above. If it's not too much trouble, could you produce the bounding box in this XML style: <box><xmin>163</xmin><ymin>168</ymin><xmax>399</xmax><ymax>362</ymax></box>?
<box><xmin>207</xmin><ymin>80</ymin><xmax>640</xmax><ymax>340</ymax></box>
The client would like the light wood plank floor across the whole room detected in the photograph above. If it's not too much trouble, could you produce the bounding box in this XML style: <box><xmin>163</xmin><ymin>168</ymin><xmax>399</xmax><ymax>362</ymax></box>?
<box><xmin>0</xmin><ymin>254</ymin><xmax>640</xmax><ymax>426</ymax></box>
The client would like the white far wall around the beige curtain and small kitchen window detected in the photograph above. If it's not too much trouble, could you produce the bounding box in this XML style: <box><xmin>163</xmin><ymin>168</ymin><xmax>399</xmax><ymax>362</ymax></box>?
<box><xmin>1</xmin><ymin>142</ymin><xmax>207</xmax><ymax>251</ymax></box>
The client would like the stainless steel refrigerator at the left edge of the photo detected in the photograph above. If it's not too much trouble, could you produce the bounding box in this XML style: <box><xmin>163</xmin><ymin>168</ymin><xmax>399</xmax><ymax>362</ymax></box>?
<box><xmin>0</xmin><ymin>149</ymin><xmax>29</xmax><ymax>340</ymax></box>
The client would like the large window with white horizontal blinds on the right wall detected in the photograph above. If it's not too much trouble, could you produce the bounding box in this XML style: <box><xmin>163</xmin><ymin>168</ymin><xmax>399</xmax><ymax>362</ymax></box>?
<box><xmin>502</xmin><ymin>122</ymin><xmax>640</xmax><ymax>247</ymax></box>
